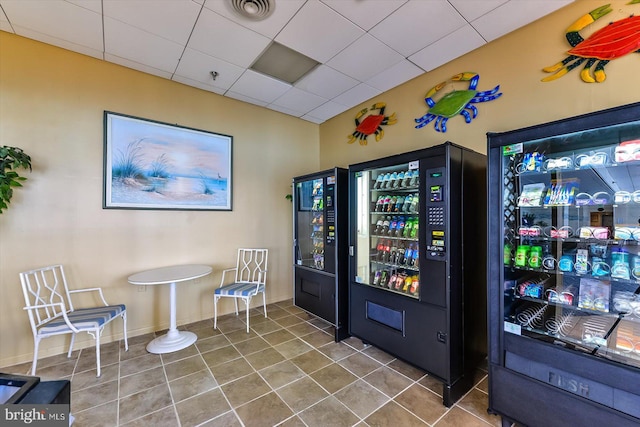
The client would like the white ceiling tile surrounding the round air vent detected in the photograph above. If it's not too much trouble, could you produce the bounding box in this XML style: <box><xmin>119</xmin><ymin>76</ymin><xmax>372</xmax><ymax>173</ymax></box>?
<box><xmin>204</xmin><ymin>0</ymin><xmax>306</xmax><ymax>39</ymax></box>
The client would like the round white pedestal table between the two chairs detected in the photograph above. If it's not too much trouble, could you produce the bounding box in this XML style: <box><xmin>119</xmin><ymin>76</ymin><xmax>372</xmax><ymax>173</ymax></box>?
<box><xmin>127</xmin><ymin>264</ymin><xmax>212</xmax><ymax>354</ymax></box>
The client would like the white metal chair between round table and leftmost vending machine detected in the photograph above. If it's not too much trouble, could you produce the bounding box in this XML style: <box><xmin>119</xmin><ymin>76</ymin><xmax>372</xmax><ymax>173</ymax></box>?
<box><xmin>213</xmin><ymin>249</ymin><xmax>269</xmax><ymax>333</ymax></box>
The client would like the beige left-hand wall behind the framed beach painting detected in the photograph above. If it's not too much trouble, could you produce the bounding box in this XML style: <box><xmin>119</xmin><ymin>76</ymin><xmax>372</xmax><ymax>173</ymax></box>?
<box><xmin>0</xmin><ymin>31</ymin><xmax>319</xmax><ymax>366</ymax></box>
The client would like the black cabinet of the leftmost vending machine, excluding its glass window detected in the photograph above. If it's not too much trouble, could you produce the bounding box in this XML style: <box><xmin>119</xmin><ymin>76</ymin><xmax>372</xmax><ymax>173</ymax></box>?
<box><xmin>293</xmin><ymin>167</ymin><xmax>349</xmax><ymax>342</ymax></box>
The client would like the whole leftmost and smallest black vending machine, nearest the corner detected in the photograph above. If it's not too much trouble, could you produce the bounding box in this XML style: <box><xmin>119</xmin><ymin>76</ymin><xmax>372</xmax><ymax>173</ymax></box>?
<box><xmin>293</xmin><ymin>168</ymin><xmax>348</xmax><ymax>341</ymax></box>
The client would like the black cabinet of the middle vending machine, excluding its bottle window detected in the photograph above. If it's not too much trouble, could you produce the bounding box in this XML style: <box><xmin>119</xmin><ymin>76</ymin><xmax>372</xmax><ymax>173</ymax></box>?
<box><xmin>349</xmin><ymin>142</ymin><xmax>487</xmax><ymax>407</ymax></box>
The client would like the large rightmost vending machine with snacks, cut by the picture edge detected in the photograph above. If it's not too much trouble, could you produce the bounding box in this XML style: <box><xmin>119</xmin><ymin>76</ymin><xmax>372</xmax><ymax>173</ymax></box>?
<box><xmin>489</xmin><ymin>104</ymin><xmax>640</xmax><ymax>425</ymax></box>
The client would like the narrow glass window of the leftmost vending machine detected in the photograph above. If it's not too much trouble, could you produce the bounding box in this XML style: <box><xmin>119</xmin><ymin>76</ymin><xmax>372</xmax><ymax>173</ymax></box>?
<box><xmin>296</xmin><ymin>178</ymin><xmax>324</xmax><ymax>270</ymax></box>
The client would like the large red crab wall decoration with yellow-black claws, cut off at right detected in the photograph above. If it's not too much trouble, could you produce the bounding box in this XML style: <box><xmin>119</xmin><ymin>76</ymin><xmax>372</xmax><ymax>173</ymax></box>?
<box><xmin>542</xmin><ymin>0</ymin><xmax>640</xmax><ymax>83</ymax></box>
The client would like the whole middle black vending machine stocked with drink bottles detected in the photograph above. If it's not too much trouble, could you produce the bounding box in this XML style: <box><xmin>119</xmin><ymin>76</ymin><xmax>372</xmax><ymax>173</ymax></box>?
<box><xmin>348</xmin><ymin>142</ymin><xmax>487</xmax><ymax>406</ymax></box>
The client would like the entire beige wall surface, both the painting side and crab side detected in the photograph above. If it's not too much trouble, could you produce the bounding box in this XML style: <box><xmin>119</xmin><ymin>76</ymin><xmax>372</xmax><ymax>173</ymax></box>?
<box><xmin>0</xmin><ymin>0</ymin><xmax>640</xmax><ymax>366</ymax></box>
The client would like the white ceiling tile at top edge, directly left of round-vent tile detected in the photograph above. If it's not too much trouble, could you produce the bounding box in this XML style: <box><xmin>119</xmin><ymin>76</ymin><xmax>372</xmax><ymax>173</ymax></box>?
<box><xmin>103</xmin><ymin>0</ymin><xmax>202</xmax><ymax>45</ymax></box>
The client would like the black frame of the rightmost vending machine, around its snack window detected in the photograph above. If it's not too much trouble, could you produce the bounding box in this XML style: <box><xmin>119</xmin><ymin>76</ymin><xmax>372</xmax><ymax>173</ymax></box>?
<box><xmin>487</xmin><ymin>103</ymin><xmax>640</xmax><ymax>427</ymax></box>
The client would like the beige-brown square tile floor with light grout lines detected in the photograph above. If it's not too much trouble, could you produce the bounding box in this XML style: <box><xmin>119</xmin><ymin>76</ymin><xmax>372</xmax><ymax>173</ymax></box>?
<box><xmin>0</xmin><ymin>300</ymin><xmax>500</xmax><ymax>427</ymax></box>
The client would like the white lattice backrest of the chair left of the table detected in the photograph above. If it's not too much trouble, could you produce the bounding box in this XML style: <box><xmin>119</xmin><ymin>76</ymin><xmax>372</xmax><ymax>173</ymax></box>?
<box><xmin>20</xmin><ymin>265</ymin><xmax>73</xmax><ymax>333</ymax></box>
